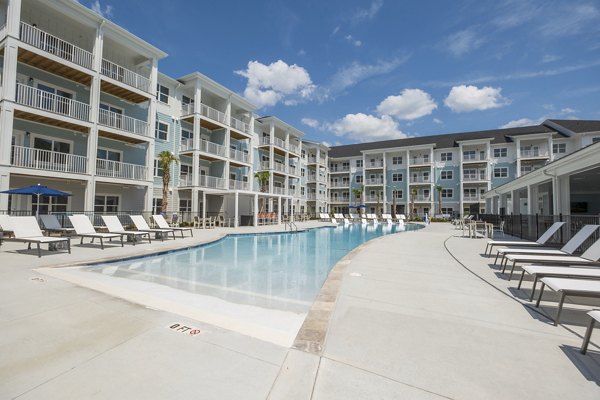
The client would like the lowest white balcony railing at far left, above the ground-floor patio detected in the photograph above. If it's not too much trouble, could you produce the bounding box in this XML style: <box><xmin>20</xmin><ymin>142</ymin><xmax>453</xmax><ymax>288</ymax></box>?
<box><xmin>11</xmin><ymin>146</ymin><xmax>87</xmax><ymax>174</ymax></box>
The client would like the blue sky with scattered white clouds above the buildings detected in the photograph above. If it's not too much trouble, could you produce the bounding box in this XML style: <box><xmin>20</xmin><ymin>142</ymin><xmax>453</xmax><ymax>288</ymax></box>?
<box><xmin>80</xmin><ymin>0</ymin><xmax>600</xmax><ymax>146</ymax></box>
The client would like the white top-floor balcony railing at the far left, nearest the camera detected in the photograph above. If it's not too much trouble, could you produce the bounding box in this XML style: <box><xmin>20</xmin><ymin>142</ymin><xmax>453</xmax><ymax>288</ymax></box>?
<box><xmin>19</xmin><ymin>22</ymin><xmax>94</xmax><ymax>69</ymax></box>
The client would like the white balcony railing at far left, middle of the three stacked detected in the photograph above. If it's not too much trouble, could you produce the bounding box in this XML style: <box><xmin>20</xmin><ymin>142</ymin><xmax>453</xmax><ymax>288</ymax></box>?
<box><xmin>17</xmin><ymin>83</ymin><xmax>90</xmax><ymax>121</ymax></box>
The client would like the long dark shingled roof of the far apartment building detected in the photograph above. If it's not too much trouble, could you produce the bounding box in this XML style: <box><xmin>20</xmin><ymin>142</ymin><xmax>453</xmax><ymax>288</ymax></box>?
<box><xmin>329</xmin><ymin>120</ymin><xmax>600</xmax><ymax>158</ymax></box>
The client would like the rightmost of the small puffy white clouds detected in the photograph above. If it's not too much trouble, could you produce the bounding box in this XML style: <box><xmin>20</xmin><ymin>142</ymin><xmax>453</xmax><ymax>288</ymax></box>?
<box><xmin>444</xmin><ymin>85</ymin><xmax>510</xmax><ymax>112</ymax></box>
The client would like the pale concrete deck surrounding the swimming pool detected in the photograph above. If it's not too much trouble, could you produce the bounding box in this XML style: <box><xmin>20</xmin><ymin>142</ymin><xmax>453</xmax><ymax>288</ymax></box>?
<box><xmin>0</xmin><ymin>222</ymin><xmax>600</xmax><ymax>400</ymax></box>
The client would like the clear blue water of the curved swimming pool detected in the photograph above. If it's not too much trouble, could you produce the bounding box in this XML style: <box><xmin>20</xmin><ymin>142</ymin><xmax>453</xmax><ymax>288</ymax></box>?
<box><xmin>84</xmin><ymin>224</ymin><xmax>417</xmax><ymax>312</ymax></box>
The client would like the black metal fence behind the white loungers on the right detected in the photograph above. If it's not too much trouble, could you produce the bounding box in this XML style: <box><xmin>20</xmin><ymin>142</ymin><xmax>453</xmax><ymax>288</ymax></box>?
<box><xmin>478</xmin><ymin>214</ymin><xmax>600</xmax><ymax>252</ymax></box>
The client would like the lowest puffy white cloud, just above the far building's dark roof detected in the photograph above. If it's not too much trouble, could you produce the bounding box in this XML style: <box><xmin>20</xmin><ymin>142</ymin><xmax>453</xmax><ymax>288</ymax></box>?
<box><xmin>326</xmin><ymin>113</ymin><xmax>407</xmax><ymax>142</ymax></box>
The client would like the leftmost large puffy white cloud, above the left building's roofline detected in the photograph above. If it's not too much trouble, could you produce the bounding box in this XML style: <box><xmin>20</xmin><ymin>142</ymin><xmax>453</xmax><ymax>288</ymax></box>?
<box><xmin>235</xmin><ymin>60</ymin><xmax>316</xmax><ymax>108</ymax></box>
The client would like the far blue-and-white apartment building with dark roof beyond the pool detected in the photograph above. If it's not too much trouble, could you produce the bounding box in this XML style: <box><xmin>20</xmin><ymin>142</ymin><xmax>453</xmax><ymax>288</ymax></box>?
<box><xmin>329</xmin><ymin>120</ymin><xmax>600</xmax><ymax>219</ymax></box>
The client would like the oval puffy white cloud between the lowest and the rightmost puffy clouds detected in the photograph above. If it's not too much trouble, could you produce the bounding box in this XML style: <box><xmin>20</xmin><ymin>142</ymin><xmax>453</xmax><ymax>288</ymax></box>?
<box><xmin>377</xmin><ymin>89</ymin><xmax>437</xmax><ymax>120</ymax></box>
